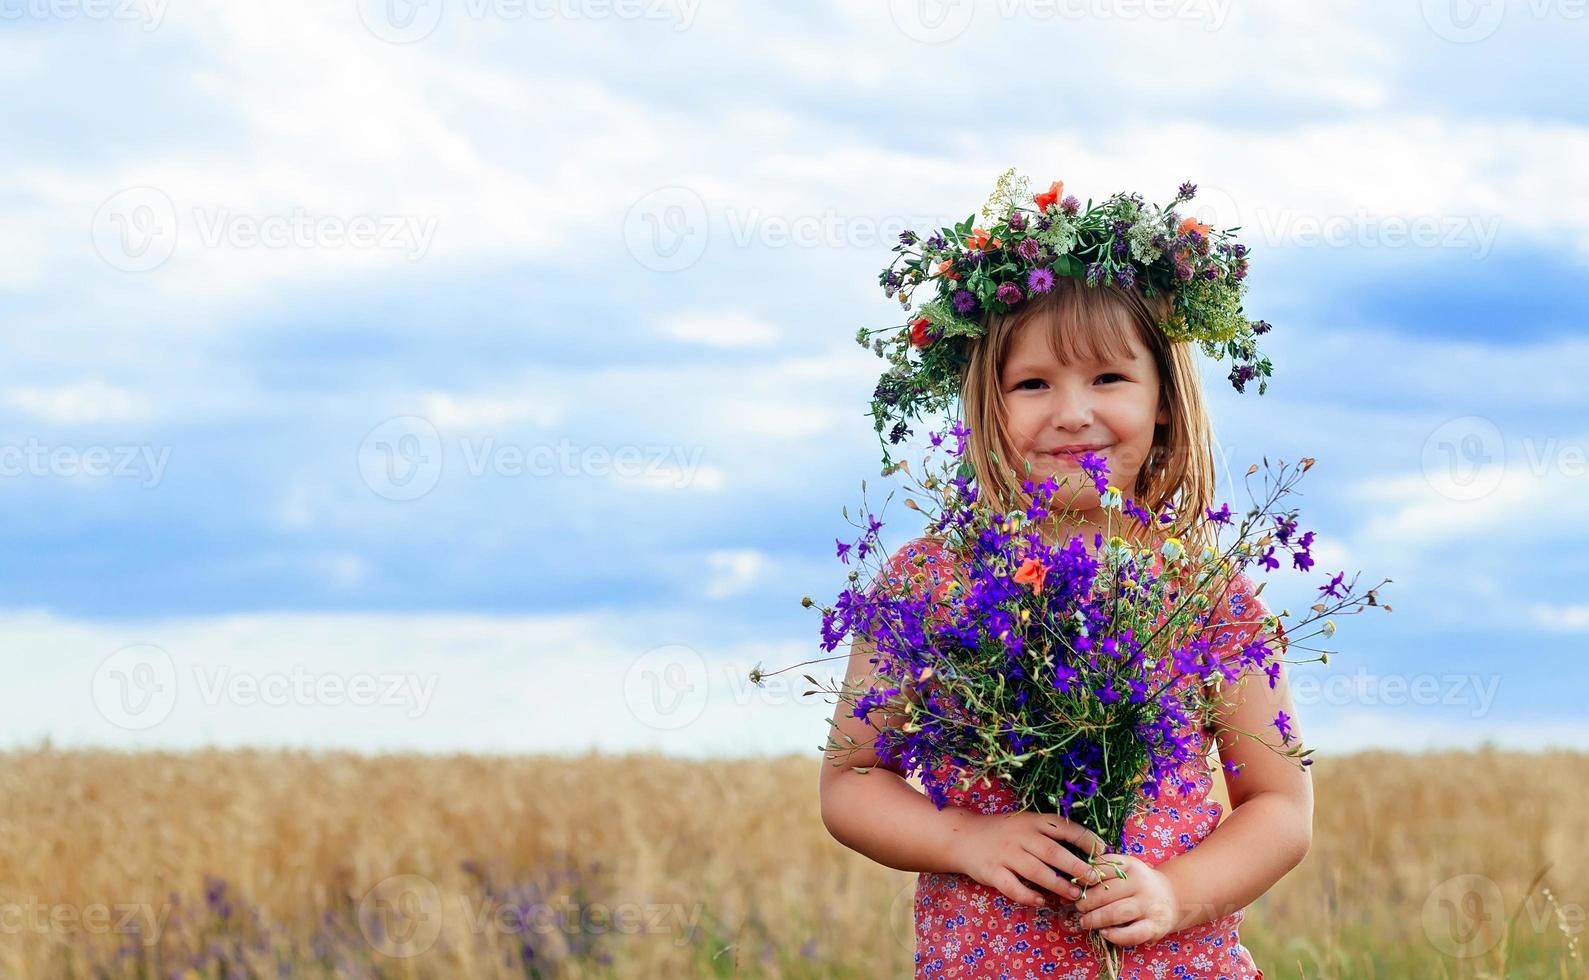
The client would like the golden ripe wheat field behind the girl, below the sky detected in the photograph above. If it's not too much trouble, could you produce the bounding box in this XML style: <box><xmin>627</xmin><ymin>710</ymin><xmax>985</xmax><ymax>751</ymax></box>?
<box><xmin>0</xmin><ymin>747</ymin><xmax>1589</xmax><ymax>978</ymax></box>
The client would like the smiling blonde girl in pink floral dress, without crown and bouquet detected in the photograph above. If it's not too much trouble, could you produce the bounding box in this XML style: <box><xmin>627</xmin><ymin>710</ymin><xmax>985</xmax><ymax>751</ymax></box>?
<box><xmin>820</xmin><ymin>270</ymin><xmax>1313</xmax><ymax>980</ymax></box>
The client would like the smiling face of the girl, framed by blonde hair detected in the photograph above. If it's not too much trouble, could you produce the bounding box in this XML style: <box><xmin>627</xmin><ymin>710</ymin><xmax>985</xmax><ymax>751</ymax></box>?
<box><xmin>999</xmin><ymin>316</ymin><xmax>1170</xmax><ymax>511</ymax></box>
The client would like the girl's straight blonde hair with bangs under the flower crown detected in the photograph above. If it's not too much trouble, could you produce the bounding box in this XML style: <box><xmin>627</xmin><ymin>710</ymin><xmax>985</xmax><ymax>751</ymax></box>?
<box><xmin>960</xmin><ymin>276</ymin><xmax>1216</xmax><ymax>553</ymax></box>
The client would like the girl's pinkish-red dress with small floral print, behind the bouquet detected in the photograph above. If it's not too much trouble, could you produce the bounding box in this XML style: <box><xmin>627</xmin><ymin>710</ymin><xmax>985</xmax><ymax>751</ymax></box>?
<box><xmin>885</xmin><ymin>538</ymin><xmax>1265</xmax><ymax>980</ymax></box>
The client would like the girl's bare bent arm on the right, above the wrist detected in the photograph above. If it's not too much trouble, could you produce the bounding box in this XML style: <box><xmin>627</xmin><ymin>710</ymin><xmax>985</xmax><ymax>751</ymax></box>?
<box><xmin>1158</xmin><ymin>577</ymin><xmax>1313</xmax><ymax>929</ymax></box>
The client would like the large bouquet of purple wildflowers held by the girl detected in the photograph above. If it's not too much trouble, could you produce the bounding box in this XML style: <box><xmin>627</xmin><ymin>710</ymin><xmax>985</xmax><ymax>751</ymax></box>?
<box><xmin>752</xmin><ymin>422</ymin><xmax>1390</xmax><ymax>967</ymax></box>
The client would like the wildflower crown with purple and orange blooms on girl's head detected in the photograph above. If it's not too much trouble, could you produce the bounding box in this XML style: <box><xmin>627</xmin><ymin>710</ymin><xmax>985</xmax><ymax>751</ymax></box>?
<box><xmin>855</xmin><ymin>167</ymin><xmax>1273</xmax><ymax>473</ymax></box>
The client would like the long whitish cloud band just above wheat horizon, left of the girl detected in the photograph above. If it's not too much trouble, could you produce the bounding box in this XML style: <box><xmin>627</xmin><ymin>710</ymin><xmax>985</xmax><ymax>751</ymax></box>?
<box><xmin>0</xmin><ymin>612</ymin><xmax>829</xmax><ymax>758</ymax></box>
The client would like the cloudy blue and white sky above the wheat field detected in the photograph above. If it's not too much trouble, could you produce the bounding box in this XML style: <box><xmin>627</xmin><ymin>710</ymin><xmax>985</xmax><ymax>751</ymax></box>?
<box><xmin>0</xmin><ymin>0</ymin><xmax>1589</xmax><ymax>754</ymax></box>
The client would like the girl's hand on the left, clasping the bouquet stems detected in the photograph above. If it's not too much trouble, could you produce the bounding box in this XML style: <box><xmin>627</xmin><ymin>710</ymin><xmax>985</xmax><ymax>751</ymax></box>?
<box><xmin>950</xmin><ymin>810</ymin><xmax>1108</xmax><ymax>909</ymax></box>
